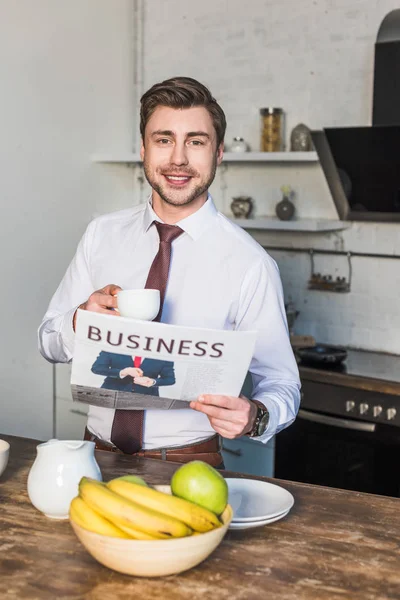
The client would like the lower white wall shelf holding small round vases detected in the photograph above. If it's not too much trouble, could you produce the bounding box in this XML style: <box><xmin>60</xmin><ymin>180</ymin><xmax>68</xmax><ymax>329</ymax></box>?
<box><xmin>227</xmin><ymin>215</ymin><xmax>351</xmax><ymax>232</ymax></box>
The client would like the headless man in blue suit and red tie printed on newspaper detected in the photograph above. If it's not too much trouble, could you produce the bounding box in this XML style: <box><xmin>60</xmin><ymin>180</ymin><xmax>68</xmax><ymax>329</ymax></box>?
<box><xmin>91</xmin><ymin>351</ymin><xmax>175</xmax><ymax>396</ymax></box>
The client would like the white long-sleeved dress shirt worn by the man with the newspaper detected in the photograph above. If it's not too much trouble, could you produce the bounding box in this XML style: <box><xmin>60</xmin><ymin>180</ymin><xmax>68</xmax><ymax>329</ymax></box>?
<box><xmin>39</xmin><ymin>196</ymin><xmax>300</xmax><ymax>449</ymax></box>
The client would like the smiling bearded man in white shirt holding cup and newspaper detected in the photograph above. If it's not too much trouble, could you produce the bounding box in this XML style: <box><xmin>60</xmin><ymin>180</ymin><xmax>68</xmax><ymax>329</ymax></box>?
<box><xmin>39</xmin><ymin>77</ymin><xmax>300</xmax><ymax>465</ymax></box>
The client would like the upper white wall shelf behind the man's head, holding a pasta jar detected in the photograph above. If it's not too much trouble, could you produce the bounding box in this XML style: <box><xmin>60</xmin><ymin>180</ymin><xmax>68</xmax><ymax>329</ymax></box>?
<box><xmin>91</xmin><ymin>152</ymin><xmax>318</xmax><ymax>164</ymax></box>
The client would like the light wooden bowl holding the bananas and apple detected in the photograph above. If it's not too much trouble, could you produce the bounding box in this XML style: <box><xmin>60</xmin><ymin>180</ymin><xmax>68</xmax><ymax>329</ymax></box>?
<box><xmin>70</xmin><ymin>485</ymin><xmax>233</xmax><ymax>577</ymax></box>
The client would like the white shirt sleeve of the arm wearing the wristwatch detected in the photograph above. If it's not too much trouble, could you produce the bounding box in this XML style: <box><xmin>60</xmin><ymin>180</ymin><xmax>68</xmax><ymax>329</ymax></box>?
<box><xmin>236</xmin><ymin>254</ymin><xmax>300</xmax><ymax>443</ymax></box>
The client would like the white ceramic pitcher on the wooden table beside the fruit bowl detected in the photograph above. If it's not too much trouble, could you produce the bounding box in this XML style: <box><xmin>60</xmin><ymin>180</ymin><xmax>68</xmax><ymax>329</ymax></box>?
<box><xmin>28</xmin><ymin>439</ymin><xmax>102</xmax><ymax>519</ymax></box>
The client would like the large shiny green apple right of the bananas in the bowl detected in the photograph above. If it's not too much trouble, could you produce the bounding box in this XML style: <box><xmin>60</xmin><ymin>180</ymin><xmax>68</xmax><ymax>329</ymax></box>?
<box><xmin>171</xmin><ymin>460</ymin><xmax>228</xmax><ymax>515</ymax></box>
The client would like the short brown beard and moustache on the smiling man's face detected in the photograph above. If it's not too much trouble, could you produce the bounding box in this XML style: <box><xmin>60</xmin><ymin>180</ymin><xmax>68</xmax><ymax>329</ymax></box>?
<box><xmin>143</xmin><ymin>154</ymin><xmax>217</xmax><ymax>206</ymax></box>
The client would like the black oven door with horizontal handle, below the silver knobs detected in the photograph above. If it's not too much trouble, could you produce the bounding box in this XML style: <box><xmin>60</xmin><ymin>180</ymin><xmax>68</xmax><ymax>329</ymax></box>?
<box><xmin>275</xmin><ymin>409</ymin><xmax>400</xmax><ymax>497</ymax></box>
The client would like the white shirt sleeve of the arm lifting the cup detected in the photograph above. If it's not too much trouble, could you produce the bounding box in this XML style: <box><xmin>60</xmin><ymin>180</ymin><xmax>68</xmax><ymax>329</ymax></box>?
<box><xmin>38</xmin><ymin>221</ymin><xmax>96</xmax><ymax>363</ymax></box>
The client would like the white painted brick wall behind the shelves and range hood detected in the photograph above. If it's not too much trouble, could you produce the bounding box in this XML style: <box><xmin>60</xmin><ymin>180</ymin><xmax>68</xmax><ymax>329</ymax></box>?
<box><xmin>136</xmin><ymin>0</ymin><xmax>400</xmax><ymax>353</ymax></box>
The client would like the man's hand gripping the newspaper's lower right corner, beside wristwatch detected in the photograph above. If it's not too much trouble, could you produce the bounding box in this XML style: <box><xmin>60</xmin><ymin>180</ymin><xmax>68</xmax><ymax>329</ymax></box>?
<box><xmin>190</xmin><ymin>394</ymin><xmax>257</xmax><ymax>440</ymax></box>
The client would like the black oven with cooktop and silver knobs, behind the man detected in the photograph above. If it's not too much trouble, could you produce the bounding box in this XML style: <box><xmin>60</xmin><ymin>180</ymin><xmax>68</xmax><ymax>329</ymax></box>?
<box><xmin>275</xmin><ymin>350</ymin><xmax>400</xmax><ymax>497</ymax></box>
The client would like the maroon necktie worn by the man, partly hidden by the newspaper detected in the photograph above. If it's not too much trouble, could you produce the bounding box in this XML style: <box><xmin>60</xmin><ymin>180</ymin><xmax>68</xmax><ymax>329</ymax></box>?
<box><xmin>111</xmin><ymin>221</ymin><xmax>183</xmax><ymax>454</ymax></box>
